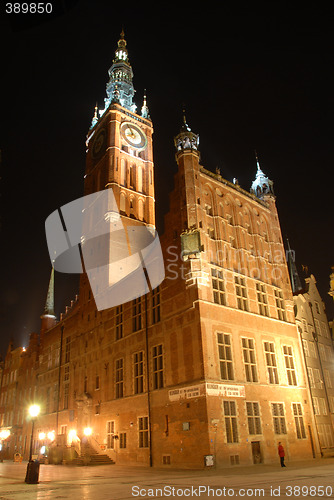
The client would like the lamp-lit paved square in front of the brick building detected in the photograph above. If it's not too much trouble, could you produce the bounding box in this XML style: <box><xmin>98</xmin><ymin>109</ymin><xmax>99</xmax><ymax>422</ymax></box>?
<box><xmin>0</xmin><ymin>458</ymin><xmax>334</xmax><ymax>500</ymax></box>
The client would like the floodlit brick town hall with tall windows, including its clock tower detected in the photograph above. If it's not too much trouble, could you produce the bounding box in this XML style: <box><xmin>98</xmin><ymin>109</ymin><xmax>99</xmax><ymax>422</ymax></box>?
<box><xmin>0</xmin><ymin>34</ymin><xmax>334</xmax><ymax>468</ymax></box>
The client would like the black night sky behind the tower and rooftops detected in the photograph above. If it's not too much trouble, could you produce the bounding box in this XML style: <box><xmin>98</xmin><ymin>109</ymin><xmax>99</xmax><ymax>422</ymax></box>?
<box><xmin>0</xmin><ymin>0</ymin><xmax>334</xmax><ymax>354</ymax></box>
